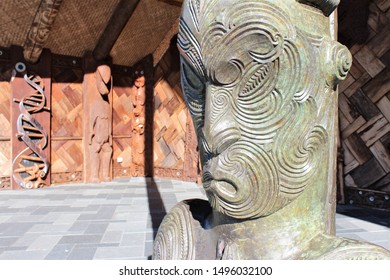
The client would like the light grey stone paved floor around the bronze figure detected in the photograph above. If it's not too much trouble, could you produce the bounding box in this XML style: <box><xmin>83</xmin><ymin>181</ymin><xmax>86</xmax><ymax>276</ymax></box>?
<box><xmin>0</xmin><ymin>178</ymin><xmax>390</xmax><ymax>260</ymax></box>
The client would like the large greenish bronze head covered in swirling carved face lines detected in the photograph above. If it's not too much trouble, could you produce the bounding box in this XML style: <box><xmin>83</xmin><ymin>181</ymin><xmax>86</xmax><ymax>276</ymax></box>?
<box><xmin>178</xmin><ymin>0</ymin><xmax>351</xmax><ymax>219</ymax></box>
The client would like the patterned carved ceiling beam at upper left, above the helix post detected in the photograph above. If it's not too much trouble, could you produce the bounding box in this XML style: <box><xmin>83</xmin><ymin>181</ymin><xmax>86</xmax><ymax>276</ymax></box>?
<box><xmin>23</xmin><ymin>0</ymin><xmax>63</xmax><ymax>64</ymax></box>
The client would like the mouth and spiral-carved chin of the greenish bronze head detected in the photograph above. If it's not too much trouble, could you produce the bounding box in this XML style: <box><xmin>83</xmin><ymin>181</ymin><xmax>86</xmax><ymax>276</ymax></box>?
<box><xmin>203</xmin><ymin>141</ymin><xmax>280</xmax><ymax>219</ymax></box>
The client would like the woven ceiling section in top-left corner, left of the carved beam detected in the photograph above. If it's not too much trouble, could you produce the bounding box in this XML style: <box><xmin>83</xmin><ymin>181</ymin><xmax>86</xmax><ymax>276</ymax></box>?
<box><xmin>0</xmin><ymin>0</ymin><xmax>40</xmax><ymax>47</ymax></box>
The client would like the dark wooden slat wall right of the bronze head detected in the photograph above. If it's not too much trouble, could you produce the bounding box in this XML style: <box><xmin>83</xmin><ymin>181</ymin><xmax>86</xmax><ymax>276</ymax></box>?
<box><xmin>339</xmin><ymin>0</ymin><xmax>390</xmax><ymax>209</ymax></box>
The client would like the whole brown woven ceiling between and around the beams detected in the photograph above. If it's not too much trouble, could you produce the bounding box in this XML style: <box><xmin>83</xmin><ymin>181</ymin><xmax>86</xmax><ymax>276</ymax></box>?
<box><xmin>0</xmin><ymin>0</ymin><xmax>182</xmax><ymax>65</ymax></box>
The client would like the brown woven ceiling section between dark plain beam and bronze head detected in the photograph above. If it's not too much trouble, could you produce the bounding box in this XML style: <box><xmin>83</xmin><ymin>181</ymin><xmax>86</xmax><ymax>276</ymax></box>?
<box><xmin>110</xmin><ymin>0</ymin><xmax>181</xmax><ymax>65</ymax></box>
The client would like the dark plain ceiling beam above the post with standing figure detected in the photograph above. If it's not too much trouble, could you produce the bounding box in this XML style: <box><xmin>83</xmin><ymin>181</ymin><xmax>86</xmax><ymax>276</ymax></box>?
<box><xmin>92</xmin><ymin>0</ymin><xmax>139</xmax><ymax>60</ymax></box>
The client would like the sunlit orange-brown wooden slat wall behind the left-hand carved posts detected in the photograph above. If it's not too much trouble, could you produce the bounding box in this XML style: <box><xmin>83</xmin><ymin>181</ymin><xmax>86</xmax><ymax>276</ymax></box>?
<box><xmin>0</xmin><ymin>46</ymin><xmax>199</xmax><ymax>189</ymax></box>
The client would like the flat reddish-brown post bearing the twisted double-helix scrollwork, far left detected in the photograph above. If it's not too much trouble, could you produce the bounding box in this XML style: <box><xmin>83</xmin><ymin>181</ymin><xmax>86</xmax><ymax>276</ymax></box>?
<box><xmin>11</xmin><ymin>46</ymin><xmax>51</xmax><ymax>189</ymax></box>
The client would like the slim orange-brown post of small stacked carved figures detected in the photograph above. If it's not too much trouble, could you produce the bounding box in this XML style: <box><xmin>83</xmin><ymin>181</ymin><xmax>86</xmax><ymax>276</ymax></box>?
<box><xmin>131</xmin><ymin>71</ymin><xmax>146</xmax><ymax>166</ymax></box>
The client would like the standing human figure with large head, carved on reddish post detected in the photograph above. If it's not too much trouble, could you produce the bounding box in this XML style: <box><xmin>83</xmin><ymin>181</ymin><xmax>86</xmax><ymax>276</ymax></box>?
<box><xmin>88</xmin><ymin>65</ymin><xmax>112</xmax><ymax>182</ymax></box>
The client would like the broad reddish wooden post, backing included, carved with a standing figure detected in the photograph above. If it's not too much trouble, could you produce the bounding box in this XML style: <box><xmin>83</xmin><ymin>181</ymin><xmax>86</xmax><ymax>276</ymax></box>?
<box><xmin>83</xmin><ymin>53</ymin><xmax>113</xmax><ymax>182</ymax></box>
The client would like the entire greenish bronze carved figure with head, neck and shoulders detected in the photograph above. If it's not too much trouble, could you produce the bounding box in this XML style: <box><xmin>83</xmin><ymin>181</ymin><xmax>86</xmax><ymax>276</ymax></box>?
<box><xmin>153</xmin><ymin>0</ymin><xmax>390</xmax><ymax>259</ymax></box>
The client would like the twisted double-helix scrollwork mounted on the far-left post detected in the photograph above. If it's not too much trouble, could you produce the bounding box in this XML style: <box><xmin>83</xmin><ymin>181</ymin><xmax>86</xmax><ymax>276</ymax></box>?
<box><xmin>12</xmin><ymin>68</ymin><xmax>50</xmax><ymax>189</ymax></box>
